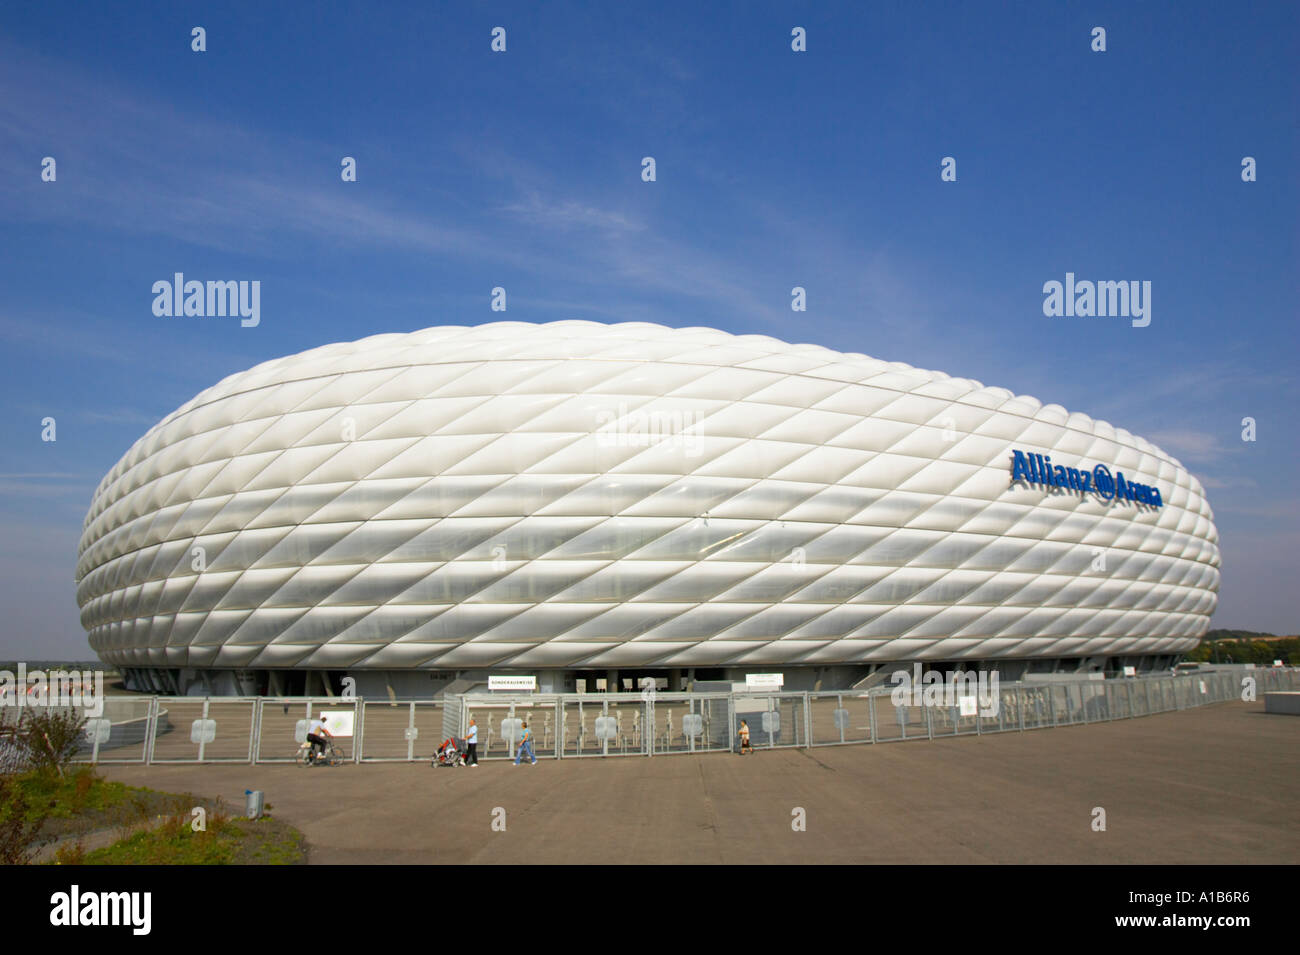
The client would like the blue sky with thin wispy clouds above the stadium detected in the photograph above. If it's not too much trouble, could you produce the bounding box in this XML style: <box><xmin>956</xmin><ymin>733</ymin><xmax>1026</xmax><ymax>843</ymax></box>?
<box><xmin>0</xmin><ymin>3</ymin><xmax>1300</xmax><ymax>656</ymax></box>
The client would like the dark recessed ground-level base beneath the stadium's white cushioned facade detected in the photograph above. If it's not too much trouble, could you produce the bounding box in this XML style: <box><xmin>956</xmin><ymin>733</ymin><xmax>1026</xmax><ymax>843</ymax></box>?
<box><xmin>118</xmin><ymin>654</ymin><xmax>1178</xmax><ymax>700</ymax></box>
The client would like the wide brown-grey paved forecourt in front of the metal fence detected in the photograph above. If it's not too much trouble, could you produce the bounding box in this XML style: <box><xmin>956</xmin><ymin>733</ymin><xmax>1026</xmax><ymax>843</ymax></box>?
<box><xmin>96</xmin><ymin>703</ymin><xmax>1300</xmax><ymax>864</ymax></box>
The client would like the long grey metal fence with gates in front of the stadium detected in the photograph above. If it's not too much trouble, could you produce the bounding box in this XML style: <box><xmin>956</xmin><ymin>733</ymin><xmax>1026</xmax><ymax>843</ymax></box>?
<box><xmin>63</xmin><ymin>668</ymin><xmax>1300</xmax><ymax>764</ymax></box>
